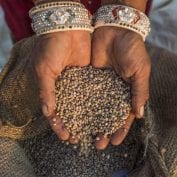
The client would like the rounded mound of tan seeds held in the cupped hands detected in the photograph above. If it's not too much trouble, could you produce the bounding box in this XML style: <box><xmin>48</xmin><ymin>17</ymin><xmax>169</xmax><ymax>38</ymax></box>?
<box><xmin>55</xmin><ymin>66</ymin><xmax>131</xmax><ymax>153</ymax></box>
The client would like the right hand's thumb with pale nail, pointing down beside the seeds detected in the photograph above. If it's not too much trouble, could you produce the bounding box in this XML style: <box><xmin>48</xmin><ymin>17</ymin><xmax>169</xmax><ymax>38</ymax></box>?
<box><xmin>131</xmin><ymin>64</ymin><xmax>150</xmax><ymax>118</ymax></box>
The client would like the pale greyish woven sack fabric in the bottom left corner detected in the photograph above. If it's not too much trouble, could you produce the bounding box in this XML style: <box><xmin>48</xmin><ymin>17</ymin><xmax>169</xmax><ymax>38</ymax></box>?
<box><xmin>0</xmin><ymin>138</ymin><xmax>36</xmax><ymax>177</ymax></box>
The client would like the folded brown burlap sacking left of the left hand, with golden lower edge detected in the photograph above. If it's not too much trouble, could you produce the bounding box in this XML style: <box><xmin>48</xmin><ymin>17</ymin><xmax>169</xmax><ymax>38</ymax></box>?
<box><xmin>0</xmin><ymin>37</ymin><xmax>48</xmax><ymax>139</ymax></box>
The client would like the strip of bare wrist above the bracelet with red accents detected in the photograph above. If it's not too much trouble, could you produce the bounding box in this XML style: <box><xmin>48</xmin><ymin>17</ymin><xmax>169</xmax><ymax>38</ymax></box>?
<box><xmin>101</xmin><ymin>0</ymin><xmax>148</xmax><ymax>12</ymax></box>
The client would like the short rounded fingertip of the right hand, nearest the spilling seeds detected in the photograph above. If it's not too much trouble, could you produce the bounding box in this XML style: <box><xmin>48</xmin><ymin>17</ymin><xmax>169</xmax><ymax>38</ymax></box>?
<box><xmin>95</xmin><ymin>135</ymin><xmax>109</xmax><ymax>150</ymax></box>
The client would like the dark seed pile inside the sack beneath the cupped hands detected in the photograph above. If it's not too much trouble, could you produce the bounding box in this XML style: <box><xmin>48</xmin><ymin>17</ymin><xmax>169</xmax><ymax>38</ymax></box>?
<box><xmin>23</xmin><ymin>126</ymin><xmax>144</xmax><ymax>177</ymax></box>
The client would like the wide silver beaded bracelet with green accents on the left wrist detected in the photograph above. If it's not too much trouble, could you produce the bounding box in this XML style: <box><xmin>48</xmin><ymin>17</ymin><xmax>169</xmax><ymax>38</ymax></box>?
<box><xmin>29</xmin><ymin>1</ymin><xmax>93</xmax><ymax>35</ymax></box>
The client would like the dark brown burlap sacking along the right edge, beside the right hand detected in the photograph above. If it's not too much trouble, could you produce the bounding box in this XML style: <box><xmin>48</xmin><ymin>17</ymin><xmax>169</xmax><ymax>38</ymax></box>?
<box><xmin>130</xmin><ymin>46</ymin><xmax>177</xmax><ymax>177</ymax></box>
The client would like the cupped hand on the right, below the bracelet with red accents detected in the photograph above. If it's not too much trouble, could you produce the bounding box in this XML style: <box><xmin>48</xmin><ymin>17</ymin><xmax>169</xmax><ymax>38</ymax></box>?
<box><xmin>91</xmin><ymin>27</ymin><xmax>151</xmax><ymax>149</ymax></box>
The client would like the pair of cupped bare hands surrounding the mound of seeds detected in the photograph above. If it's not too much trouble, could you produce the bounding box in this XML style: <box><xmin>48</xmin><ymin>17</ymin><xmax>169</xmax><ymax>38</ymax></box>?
<box><xmin>34</xmin><ymin>27</ymin><xmax>151</xmax><ymax>150</ymax></box>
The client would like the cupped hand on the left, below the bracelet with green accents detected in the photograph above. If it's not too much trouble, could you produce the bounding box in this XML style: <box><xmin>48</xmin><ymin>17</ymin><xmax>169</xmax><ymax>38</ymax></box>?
<box><xmin>34</xmin><ymin>31</ymin><xmax>91</xmax><ymax>143</ymax></box>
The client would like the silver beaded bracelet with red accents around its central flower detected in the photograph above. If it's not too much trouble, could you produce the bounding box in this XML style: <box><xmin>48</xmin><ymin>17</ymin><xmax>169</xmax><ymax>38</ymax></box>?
<box><xmin>94</xmin><ymin>4</ymin><xmax>150</xmax><ymax>40</ymax></box>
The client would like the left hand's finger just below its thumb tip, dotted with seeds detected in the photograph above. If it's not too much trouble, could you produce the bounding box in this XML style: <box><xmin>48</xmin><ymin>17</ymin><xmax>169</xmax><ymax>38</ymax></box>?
<box><xmin>49</xmin><ymin>116</ymin><xmax>70</xmax><ymax>141</ymax></box>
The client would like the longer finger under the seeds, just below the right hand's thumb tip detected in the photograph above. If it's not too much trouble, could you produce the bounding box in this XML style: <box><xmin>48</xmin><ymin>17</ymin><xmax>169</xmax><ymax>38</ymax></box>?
<box><xmin>111</xmin><ymin>113</ymin><xmax>135</xmax><ymax>145</ymax></box>
